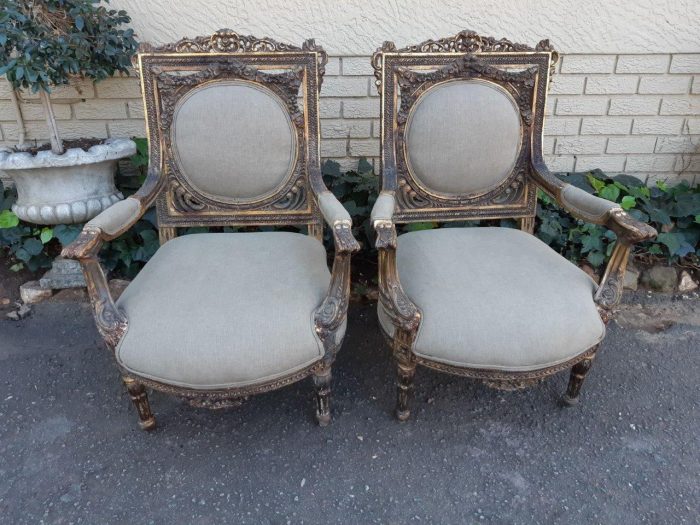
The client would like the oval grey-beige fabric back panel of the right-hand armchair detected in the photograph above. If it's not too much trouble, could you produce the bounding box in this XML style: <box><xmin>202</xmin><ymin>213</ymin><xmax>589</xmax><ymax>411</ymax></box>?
<box><xmin>405</xmin><ymin>80</ymin><xmax>521</xmax><ymax>195</ymax></box>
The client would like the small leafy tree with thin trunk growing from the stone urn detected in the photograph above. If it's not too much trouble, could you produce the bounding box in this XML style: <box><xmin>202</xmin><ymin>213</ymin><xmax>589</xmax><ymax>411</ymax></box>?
<box><xmin>0</xmin><ymin>0</ymin><xmax>138</xmax><ymax>155</ymax></box>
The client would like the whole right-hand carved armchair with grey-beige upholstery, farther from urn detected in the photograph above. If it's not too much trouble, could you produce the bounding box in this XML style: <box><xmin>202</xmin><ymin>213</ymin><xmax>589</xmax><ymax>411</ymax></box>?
<box><xmin>372</xmin><ymin>31</ymin><xmax>656</xmax><ymax>420</ymax></box>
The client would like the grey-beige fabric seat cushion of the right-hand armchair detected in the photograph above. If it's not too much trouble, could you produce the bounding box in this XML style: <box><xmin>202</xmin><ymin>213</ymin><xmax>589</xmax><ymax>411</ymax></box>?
<box><xmin>379</xmin><ymin>228</ymin><xmax>605</xmax><ymax>371</ymax></box>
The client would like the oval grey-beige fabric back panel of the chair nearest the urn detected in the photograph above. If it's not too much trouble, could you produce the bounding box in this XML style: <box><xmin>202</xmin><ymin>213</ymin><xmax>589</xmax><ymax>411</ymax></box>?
<box><xmin>171</xmin><ymin>80</ymin><xmax>297</xmax><ymax>201</ymax></box>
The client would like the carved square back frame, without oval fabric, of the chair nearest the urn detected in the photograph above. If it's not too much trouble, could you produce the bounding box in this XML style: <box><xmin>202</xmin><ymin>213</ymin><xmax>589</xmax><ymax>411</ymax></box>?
<box><xmin>138</xmin><ymin>37</ymin><xmax>327</xmax><ymax>231</ymax></box>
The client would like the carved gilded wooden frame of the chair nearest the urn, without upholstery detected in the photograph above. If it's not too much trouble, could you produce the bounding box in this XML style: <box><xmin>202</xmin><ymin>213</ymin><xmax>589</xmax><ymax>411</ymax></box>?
<box><xmin>63</xmin><ymin>29</ymin><xmax>359</xmax><ymax>429</ymax></box>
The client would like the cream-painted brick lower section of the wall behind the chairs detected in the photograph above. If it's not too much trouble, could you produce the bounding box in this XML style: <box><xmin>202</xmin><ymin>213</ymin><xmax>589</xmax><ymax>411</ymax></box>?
<box><xmin>0</xmin><ymin>54</ymin><xmax>700</xmax><ymax>183</ymax></box>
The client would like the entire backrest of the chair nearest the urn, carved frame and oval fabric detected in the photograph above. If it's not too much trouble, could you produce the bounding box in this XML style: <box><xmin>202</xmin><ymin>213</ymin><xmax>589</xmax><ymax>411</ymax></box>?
<box><xmin>138</xmin><ymin>30</ymin><xmax>327</xmax><ymax>228</ymax></box>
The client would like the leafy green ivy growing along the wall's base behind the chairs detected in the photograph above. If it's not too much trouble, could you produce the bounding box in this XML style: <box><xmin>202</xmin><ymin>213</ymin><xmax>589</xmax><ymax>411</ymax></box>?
<box><xmin>0</xmin><ymin>156</ymin><xmax>700</xmax><ymax>278</ymax></box>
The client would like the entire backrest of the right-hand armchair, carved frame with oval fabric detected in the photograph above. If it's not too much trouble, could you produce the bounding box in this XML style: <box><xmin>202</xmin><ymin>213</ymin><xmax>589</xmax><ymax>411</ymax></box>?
<box><xmin>372</xmin><ymin>31</ymin><xmax>558</xmax><ymax>222</ymax></box>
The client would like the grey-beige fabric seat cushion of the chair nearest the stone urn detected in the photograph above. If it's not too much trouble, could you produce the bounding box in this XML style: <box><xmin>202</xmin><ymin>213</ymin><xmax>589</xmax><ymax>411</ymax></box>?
<box><xmin>116</xmin><ymin>232</ymin><xmax>330</xmax><ymax>389</ymax></box>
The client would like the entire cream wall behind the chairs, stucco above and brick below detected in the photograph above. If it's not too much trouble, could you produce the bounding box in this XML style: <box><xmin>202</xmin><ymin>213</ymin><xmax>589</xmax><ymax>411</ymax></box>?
<box><xmin>0</xmin><ymin>0</ymin><xmax>700</xmax><ymax>182</ymax></box>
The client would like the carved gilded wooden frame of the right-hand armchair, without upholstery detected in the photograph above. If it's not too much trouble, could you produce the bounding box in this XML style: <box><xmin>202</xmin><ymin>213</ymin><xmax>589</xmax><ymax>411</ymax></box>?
<box><xmin>372</xmin><ymin>31</ymin><xmax>656</xmax><ymax>420</ymax></box>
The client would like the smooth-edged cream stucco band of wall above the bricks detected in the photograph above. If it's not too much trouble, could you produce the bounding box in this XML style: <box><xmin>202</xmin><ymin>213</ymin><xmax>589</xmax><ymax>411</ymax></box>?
<box><xmin>111</xmin><ymin>0</ymin><xmax>700</xmax><ymax>55</ymax></box>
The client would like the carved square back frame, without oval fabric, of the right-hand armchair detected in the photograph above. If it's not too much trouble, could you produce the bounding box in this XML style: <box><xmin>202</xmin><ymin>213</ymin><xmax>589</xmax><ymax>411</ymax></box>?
<box><xmin>373</xmin><ymin>32</ymin><xmax>557</xmax><ymax>223</ymax></box>
